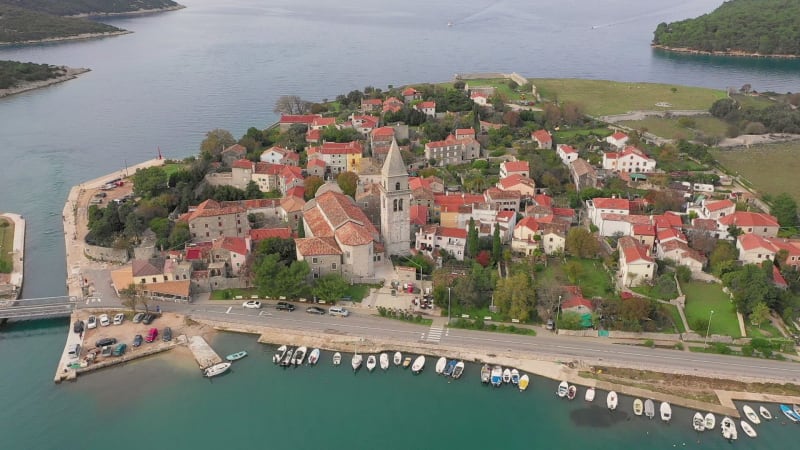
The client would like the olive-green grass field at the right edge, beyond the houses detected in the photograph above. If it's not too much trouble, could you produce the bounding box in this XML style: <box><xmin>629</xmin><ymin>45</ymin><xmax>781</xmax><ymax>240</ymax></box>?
<box><xmin>711</xmin><ymin>142</ymin><xmax>800</xmax><ymax>202</ymax></box>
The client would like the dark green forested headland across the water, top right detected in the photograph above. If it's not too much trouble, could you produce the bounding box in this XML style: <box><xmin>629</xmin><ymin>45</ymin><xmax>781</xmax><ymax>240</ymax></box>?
<box><xmin>653</xmin><ymin>0</ymin><xmax>800</xmax><ymax>56</ymax></box>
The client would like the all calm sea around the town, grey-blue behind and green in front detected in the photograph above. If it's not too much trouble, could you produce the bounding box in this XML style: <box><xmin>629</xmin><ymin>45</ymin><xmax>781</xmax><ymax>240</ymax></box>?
<box><xmin>0</xmin><ymin>0</ymin><xmax>800</xmax><ymax>449</ymax></box>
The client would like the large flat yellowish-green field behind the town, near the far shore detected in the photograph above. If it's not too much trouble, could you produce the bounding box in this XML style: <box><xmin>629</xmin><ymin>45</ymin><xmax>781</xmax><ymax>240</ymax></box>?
<box><xmin>530</xmin><ymin>78</ymin><xmax>725</xmax><ymax>116</ymax></box>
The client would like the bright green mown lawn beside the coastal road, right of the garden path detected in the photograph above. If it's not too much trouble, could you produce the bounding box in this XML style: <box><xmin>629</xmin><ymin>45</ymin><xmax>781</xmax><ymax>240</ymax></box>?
<box><xmin>681</xmin><ymin>281</ymin><xmax>742</xmax><ymax>338</ymax></box>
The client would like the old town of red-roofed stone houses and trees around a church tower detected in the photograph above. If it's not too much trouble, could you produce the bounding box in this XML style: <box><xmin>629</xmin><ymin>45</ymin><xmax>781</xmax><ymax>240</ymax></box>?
<box><xmin>86</xmin><ymin>74</ymin><xmax>800</xmax><ymax>353</ymax></box>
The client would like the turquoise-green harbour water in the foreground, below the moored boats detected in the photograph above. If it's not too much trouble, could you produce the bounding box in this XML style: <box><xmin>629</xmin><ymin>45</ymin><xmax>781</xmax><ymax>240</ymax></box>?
<box><xmin>0</xmin><ymin>321</ymin><xmax>800</xmax><ymax>450</ymax></box>
